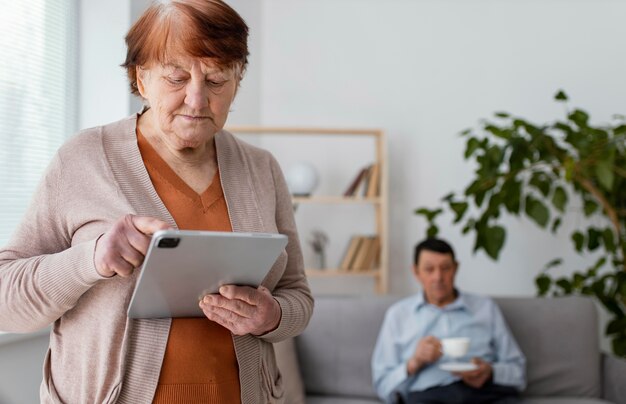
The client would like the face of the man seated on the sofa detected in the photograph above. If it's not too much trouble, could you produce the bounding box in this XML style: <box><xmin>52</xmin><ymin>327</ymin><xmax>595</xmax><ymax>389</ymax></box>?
<box><xmin>413</xmin><ymin>250</ymin><xmax>458</xmax><ymax>307</ymax></box>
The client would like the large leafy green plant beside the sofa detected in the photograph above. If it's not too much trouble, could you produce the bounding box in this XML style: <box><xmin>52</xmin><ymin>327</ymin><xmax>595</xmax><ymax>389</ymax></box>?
<box><xmin>415</xmin><ymin>91</ymin><xmax>626</xmax><ymax>357</ymax></box>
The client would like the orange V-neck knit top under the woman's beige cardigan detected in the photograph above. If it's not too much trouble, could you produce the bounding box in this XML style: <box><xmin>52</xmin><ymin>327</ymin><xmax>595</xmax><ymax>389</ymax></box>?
<box><xmin>137</xmin><ymin>129</ymin><xmax>241</xmax><ymax>404</ymax></box>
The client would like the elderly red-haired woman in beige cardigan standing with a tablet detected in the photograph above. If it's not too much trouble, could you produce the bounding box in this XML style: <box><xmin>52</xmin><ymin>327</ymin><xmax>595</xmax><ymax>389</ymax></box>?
<box><xmin>0</xmin><ymin>0</ymin><xmax>313</xmax><ymax>404</ymax></box>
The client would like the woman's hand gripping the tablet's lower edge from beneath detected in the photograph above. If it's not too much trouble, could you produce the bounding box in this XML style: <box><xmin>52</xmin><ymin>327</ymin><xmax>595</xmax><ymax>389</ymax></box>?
<box><xmin>200</xmin><ymin>285</ymin><xmax>282</xmax><ymax>335</ymax></box>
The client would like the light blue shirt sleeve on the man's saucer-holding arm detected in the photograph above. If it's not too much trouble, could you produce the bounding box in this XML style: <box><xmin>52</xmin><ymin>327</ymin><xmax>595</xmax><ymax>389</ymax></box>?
<box><xmin>492</xmin><ymin>302</ymin><xmax>526</xmax><ymax>391</ymax></box>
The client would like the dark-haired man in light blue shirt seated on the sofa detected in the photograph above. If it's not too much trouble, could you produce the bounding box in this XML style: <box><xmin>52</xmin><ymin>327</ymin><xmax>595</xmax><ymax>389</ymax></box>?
<box><xmin>372</xmin><ymin>238</ymin><xmax>526</xmax><ymax>404</ymax></box>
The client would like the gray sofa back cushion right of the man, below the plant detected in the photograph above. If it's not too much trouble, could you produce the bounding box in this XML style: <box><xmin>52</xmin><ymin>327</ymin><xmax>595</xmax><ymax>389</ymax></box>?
<box><xmin>494</xmin><ymin>297</ymin><xmax>602</xmax><ymax>402</ymax></box>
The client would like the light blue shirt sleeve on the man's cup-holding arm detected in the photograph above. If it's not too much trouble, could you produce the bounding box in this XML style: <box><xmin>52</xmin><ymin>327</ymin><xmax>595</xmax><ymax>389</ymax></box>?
<box><xmin>372</xmin><ymin>311</ymin><xmax>409</xmax><ymax>403</ymax></box>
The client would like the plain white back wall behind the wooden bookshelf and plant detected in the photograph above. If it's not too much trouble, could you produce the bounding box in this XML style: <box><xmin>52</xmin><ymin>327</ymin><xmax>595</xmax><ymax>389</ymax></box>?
<box><xmin>260</xmin><ymin>0</ymin><xmax>626</xmax><ymax>295</ymax></box>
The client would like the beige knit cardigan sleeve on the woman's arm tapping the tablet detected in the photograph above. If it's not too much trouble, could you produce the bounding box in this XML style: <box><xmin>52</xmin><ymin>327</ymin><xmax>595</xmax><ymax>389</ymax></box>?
<box><xmin>0</xmin><ymin>154</ymin><xmax>103</xmax><ymax>332</ymax></box>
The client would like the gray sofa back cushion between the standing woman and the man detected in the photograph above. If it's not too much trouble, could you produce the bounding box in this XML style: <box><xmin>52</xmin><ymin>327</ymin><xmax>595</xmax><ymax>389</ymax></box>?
<box><xmin>296</xmin><ymin>296</ymin><xmax>398</xmax><ymax>399</ymax></box>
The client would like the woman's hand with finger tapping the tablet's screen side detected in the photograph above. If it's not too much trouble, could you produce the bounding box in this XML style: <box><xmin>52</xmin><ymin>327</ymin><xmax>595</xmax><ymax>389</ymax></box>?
<box><xmin>94</xmin><ymin>215</ymin><xmax>172</xmax><ymax>277</ymax></box>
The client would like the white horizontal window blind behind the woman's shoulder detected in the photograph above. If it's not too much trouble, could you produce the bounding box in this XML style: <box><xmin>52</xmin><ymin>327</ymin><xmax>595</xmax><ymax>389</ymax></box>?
<box><xmin>0</xmin><ymin>0</ymin><xmax>78</xmax><ymax>246</ymax></box>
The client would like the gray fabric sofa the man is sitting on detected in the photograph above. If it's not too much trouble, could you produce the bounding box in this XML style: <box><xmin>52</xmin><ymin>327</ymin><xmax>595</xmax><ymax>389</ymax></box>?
<box><xmin>295</xmin><ymin>296</ymin><xmax>626</xmax><ymax>404</ymax></box>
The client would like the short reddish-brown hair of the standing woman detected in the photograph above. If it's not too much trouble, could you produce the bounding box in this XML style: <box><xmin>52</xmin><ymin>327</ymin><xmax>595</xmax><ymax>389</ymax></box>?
<box><xmin>122</xmin><ymin>0</ymin><xmax>249</xmax><ymax>95</ymax></box>
